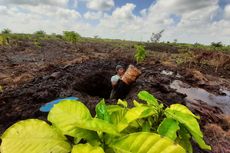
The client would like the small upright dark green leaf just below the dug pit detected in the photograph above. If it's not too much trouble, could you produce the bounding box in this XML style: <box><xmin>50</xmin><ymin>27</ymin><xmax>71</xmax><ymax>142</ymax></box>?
<box><xmin>96</xmin><ymin>99</ymin><xmax>110</xmax><ymax>122</ymax></box>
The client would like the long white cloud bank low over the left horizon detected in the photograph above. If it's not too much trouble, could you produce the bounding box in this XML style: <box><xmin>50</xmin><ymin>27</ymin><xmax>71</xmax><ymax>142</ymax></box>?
<box><xmin>0</xmin><ymin>5</ymin><xmax>82</xmax><ymax>33</ymax></box>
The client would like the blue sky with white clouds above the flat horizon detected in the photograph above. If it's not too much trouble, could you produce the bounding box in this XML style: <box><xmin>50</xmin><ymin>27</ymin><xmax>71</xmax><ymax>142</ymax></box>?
<box><xmin>0</xmin><ymin>0</ymin><xmax>230</xmax><ymax>45</ymax></box>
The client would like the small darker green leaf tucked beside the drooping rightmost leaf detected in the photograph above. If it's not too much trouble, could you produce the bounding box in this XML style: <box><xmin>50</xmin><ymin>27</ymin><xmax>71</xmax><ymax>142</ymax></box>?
<box><xmin>157</xmin><ymin>118</ymin><xmax>180</xmax><ymax>140</ymax></box>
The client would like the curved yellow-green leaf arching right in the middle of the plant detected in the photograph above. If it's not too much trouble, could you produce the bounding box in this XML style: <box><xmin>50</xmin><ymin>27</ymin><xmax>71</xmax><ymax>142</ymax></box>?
<box><xmin>117</xmin><ymin>106</ymin><xmax>157</xmax><ymax>131</ymax></box>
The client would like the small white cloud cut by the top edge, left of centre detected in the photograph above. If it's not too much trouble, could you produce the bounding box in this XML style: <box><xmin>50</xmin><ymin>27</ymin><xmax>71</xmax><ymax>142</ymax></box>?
<box><xmin>86</xmin><ymin>0</ymin><xmax>115</xmax><ymax>11</ymax></box>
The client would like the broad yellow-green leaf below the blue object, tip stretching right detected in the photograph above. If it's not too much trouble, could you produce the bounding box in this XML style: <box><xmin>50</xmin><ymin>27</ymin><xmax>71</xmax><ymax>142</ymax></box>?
<box><xmin>48</xmin><ymin>100</ymin><xmax>118</xmax><ymax>137</ymax></box>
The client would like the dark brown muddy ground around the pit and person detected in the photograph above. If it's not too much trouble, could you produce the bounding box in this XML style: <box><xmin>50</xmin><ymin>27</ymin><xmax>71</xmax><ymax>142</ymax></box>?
<box><xmin>0</xmin><ymin>41</ymin><xmax>230</xmax><ymax>153</ymax></box>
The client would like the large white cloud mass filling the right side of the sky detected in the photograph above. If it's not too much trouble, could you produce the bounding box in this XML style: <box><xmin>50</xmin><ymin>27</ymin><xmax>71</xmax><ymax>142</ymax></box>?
<box><xmin>91</xmin><ymin>0</ymin><xmax>230</xmax><ymax>44</ymax></box>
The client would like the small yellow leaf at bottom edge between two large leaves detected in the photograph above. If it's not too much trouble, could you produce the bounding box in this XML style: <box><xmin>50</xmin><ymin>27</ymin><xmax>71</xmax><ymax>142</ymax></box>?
<box><xmin>71</xmin><ymin>143</ymin><xmax>104</xmax><ymax>153</ymax></box>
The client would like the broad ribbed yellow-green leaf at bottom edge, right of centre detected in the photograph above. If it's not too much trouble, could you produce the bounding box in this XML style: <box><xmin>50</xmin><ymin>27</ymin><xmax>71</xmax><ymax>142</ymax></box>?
<box><xmin>111</xmin><ymin>132</ymin><xmax>186</xmax><ymax>153</ymax></box>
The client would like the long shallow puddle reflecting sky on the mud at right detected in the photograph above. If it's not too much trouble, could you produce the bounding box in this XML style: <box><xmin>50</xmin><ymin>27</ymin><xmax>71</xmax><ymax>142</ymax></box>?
<box><xmin>170</xmin><ymin>80</ymin><xmax>230</xmax><ymax>114</ymax></box>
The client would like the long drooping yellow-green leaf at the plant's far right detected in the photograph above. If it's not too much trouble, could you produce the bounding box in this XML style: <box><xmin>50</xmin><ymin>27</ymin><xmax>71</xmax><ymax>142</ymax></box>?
<box><xmin>165</xmin><ymin>107</ymin><xmax>211</xmax><ymax>150</ymax></box>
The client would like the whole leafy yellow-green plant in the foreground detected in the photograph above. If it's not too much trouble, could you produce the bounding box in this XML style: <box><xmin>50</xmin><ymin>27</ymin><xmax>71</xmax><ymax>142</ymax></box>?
<box><xmin>1</xmin><ymin>91</ymin><xmax>211</xmax><ymax>153</ymax></box>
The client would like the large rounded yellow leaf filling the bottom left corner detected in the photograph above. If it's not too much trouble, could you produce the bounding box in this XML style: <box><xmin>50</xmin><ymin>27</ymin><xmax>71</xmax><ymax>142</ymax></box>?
<box><xmin>1</xmin><ymin>119</ymin><xmax>71</xmax><ymax>153</ymax></box>
